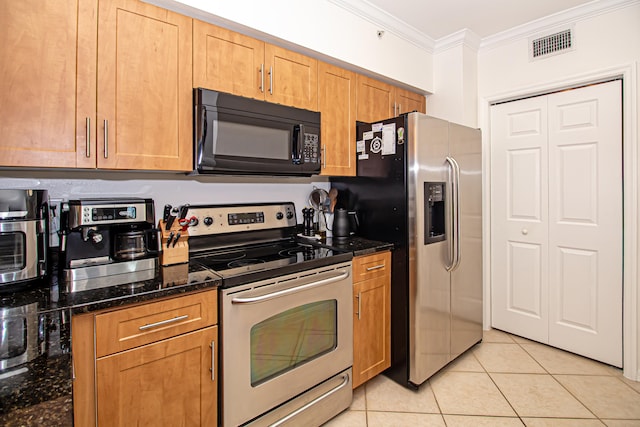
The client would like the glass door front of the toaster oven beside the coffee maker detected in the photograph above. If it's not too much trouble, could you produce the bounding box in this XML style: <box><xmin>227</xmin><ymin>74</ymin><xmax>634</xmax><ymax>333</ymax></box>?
<box><xmin>0</xmin><ymin>220</ymin><xmax>46</xmax><ymax>285</ymax></box>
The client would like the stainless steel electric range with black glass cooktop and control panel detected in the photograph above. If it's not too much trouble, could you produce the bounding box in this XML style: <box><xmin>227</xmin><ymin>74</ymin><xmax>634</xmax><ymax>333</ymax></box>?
<box><xmin>187</xmin><ymin>203</ymin><xmax>353</xmax><ymax>426</ymax></box>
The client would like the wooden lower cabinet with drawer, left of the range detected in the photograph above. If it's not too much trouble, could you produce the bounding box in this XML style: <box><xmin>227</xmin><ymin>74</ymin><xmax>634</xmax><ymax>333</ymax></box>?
<box><xmin>72</xmin><ymin>290</ymin><xmax>218</xmax><ymax>427</ymax></box>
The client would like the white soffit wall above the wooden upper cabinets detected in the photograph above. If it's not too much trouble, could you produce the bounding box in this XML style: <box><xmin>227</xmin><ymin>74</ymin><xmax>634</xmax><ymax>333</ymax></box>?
<box><xmin>145</xmin><ymin>0</ymin><xmax>433</xmax><ymax>92</ymax></box>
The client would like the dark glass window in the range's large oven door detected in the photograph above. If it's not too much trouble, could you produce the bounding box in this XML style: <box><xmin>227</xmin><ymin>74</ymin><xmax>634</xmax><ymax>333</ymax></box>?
<box><xmin>251</xmin><ymin>300</ymin><xmax>338</xmax><ymax>387</ymax></box>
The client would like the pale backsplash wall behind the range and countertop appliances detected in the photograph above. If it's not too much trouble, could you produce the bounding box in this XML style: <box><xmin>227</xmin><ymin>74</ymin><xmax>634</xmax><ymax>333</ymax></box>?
<box><xmin>0</xmin><ymin>171</ymin><xmax>329</xmax><ymax>246</ymax></box>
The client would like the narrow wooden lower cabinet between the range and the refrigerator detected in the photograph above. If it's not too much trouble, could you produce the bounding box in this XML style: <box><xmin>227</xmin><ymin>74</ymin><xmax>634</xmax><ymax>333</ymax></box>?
<box><xmin>353</xmin><ymin>251</ymin><xmax>391</xmax><ymax>388</ymax></box>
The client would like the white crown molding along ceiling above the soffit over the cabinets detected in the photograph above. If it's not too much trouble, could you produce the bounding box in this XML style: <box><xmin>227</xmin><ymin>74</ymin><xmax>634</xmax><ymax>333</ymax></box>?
<box><xmin>328</xmin><ymin>0</ymin><xmax>435</xmax><ymax>53</ymax></box>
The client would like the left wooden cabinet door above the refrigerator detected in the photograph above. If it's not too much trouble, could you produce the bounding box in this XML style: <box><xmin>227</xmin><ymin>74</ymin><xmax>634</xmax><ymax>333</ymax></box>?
<box><xmin>356</xmin><ymin>75</ymin><xmax>395</xmax><ymax>123</ymax></box>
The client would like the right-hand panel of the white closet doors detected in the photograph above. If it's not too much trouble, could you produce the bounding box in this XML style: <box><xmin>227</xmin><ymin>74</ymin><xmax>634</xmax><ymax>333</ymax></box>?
<box><xmin>548</xmin><ymin>81</ymin><xmax>623</xmax><ymax>367</ymax></box>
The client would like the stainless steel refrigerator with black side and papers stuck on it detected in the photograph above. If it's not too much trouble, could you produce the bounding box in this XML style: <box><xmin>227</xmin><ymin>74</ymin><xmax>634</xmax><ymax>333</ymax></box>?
<box><xmin>331</xmin><ymin>112</ymin><xmax>482</xmax><ymax>388</ymax></box>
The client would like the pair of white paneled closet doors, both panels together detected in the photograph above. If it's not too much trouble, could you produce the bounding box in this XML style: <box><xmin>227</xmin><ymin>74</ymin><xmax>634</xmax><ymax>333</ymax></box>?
<box><xmin>491</xmin><ymin>81</ymin><xmax>623</xmax><ymax>366</ymax></box>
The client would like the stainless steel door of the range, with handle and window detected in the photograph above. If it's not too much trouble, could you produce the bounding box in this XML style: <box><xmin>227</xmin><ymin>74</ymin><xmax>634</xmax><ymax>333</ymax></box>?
<box><xmin>221</xmin><ymin>263</ymin><xmax>353</xmax><ymax>426</ymax></box>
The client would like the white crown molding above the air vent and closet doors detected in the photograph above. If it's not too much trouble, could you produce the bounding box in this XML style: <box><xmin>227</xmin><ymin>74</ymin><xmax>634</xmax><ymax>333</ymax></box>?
<box><xmin>480</xmin><ymin>0</ymin><xmax>640</xmax><ymax>50</ymax></box>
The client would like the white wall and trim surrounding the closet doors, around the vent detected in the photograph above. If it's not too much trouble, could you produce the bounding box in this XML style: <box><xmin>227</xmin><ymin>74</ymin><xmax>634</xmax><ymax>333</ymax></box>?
<box><xmin>478</xmin><ymin>1</ymin><xmax>640</xmax><ymax>380</ymax></box>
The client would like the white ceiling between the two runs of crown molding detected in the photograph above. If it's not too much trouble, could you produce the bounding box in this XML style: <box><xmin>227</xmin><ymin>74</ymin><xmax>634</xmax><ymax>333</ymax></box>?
<box><xmin>362</xmin><ymin>0</ymin><xmax>603</xmax><ymax>40</ymax></box>
